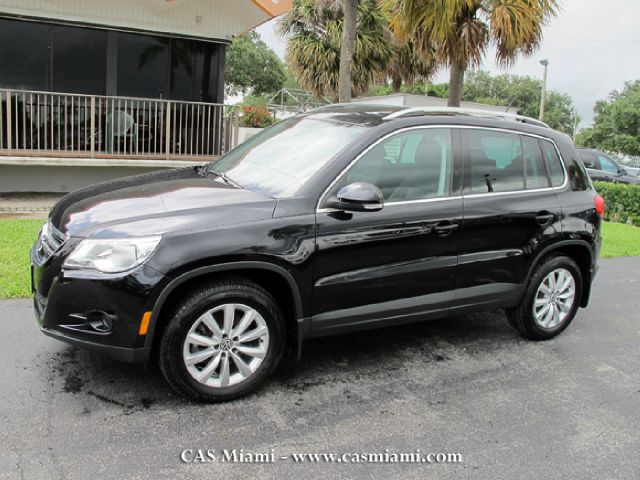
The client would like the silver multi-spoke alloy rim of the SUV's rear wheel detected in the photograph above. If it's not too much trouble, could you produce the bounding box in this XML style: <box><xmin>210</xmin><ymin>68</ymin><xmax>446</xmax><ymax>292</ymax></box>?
<box><xmin>533</xmin><ymin>268</ymin><xmax>576</xmax><ymax>329</ymax></box>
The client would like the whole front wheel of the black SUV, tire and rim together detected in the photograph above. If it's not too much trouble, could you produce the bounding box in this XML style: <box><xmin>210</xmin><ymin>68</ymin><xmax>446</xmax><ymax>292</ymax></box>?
<box><xmin>159</xmin><ymin>278</ymin><xmax>285</xmax><ymax>402</ymax></box>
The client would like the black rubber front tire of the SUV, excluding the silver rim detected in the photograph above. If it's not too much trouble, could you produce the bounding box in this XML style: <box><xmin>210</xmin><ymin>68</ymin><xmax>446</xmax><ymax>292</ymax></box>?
<box><xmin>158</xmin><ymin>278</ymin><xmax>286</xmax><ymax>402</ymax></box>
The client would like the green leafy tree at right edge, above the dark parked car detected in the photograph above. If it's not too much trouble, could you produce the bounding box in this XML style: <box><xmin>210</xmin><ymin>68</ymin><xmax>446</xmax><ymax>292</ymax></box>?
<box><xmin>576</xmin><ymin>80</ymin><xmax>640</xmax><ymax>155</ymax></box>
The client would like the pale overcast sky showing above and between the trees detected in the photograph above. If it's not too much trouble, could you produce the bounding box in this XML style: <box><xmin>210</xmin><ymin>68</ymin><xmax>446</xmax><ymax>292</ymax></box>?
<box><xmin>257</xmin><ymin>0</ymin><xmax>640</xmax><ymax>127</ymax></box>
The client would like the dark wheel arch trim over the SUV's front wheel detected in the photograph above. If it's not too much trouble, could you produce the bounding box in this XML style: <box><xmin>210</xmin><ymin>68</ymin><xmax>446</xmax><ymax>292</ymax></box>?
<box><xmin>145</xmin><ymin>261</ymin><xmax>304</xmax><ymax>355</ymax></box>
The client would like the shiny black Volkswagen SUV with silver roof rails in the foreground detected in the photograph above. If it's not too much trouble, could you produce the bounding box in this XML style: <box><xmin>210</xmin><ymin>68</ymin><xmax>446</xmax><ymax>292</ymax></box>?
<box><xmin>31</xmin><ymin>105</ymin><xmax>604</xmax><ymax>401</ymax></box>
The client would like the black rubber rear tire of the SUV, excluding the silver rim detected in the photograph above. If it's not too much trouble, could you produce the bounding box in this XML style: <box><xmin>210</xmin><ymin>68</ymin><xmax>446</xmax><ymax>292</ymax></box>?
<box><xmin>507</xmin><ymin>254</ymin><xmax>582</xmax><ymax>340</ymax></box>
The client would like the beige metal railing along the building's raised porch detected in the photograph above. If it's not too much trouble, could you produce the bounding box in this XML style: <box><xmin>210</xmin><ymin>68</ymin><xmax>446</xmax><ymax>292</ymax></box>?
<box><xmin>0</xmin><ymin>89</ymin><xmax>238</xmax><ymax>159</ymax></box>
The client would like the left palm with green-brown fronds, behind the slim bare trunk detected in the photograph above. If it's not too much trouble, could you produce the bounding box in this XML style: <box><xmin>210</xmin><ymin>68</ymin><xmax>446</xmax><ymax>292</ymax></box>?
<box><xmin>279</xmin><ymin>0</ymin><xmax>392</xmax><ymax>102</ymax></box>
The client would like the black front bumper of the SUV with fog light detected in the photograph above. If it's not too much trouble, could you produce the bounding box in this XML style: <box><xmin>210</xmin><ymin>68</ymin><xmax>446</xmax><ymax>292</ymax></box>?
<box><xmin>31</xmin><ymin>244</ymin><xmax>167</xmax><ymax>362</ymax></box>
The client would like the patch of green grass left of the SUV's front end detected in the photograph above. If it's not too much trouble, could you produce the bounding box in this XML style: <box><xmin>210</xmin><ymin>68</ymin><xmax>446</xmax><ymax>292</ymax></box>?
<box><xmin>0</xmin><ymin>220</ymin><xmax>43</xmax><ymax>298</ymax></box>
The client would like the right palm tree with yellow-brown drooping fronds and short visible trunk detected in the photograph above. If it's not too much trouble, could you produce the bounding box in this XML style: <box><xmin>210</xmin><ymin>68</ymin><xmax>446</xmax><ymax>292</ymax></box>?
<box><xmin>384</xmin><ymin>0</ymin><xmax>559</xmax><ymax>107</ymax></box>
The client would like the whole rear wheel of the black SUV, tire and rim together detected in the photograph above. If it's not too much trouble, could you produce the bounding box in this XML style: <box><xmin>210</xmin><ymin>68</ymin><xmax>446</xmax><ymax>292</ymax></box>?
<box><xmin>507</xmin><ymin>255</ymin><xmax>582</xmax><ymax>340</ymax></box>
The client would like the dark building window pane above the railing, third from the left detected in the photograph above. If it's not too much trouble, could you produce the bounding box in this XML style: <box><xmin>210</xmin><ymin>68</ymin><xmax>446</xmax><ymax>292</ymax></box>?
<box><xmin>118</xmin><ymin>33</ymin><xmax>169</xmax><ymax>97</ymax></box>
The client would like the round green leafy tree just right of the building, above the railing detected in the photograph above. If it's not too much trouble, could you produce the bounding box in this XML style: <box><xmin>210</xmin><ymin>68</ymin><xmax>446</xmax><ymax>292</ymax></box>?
<box><xmin>225</xmin><ymin>31</ymin><xmax>286</xmax><ymax>95</ymax></box>
